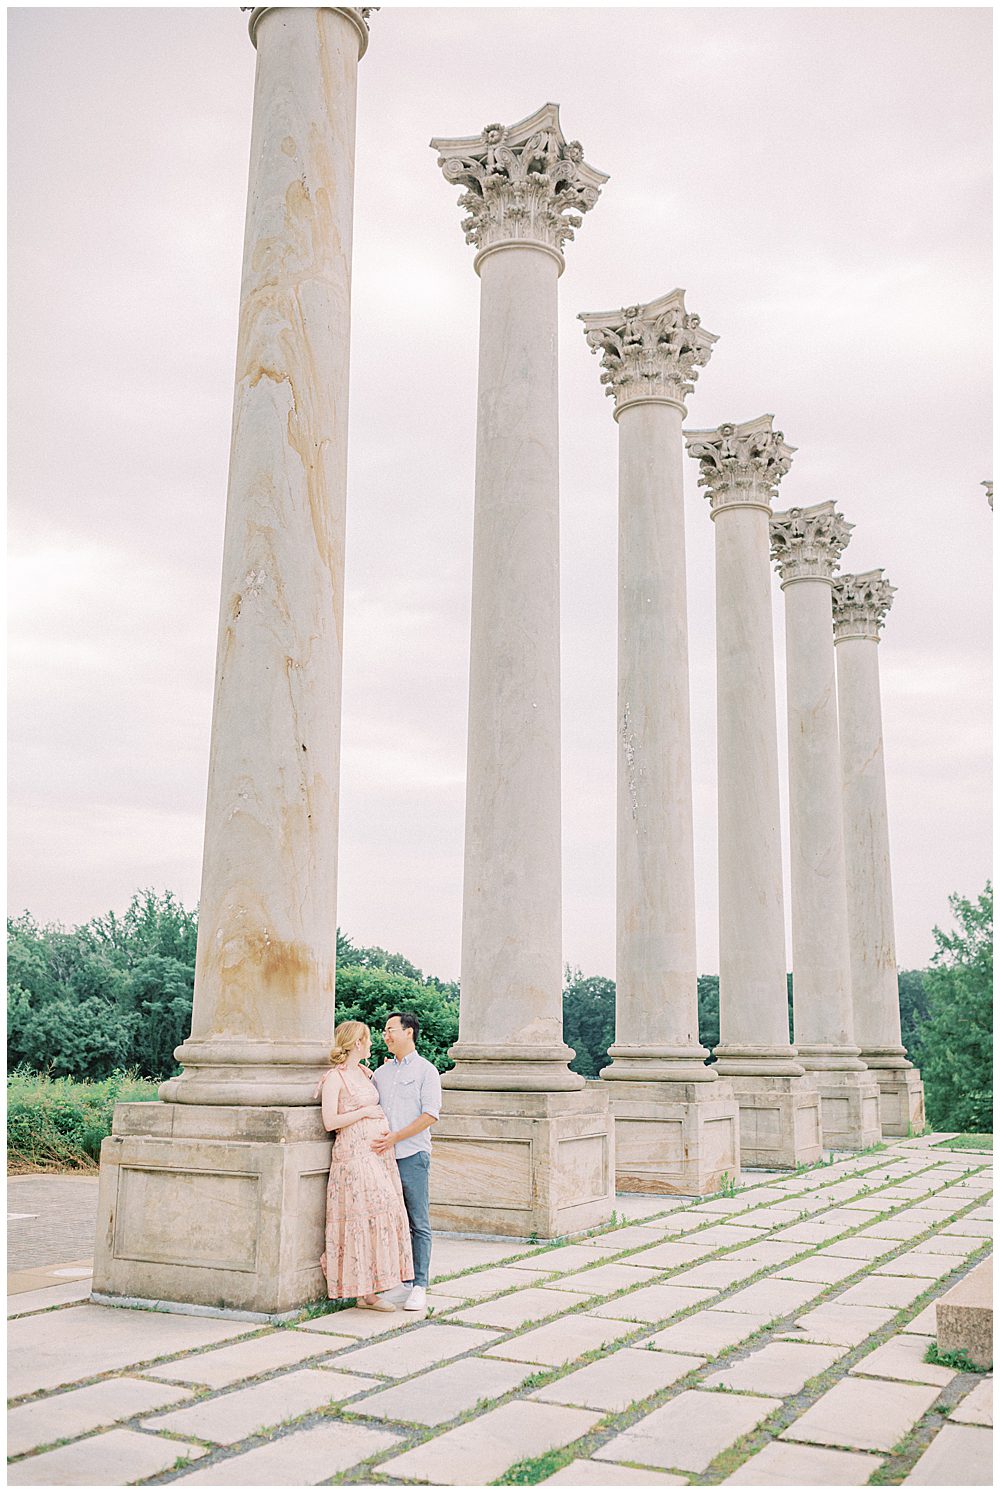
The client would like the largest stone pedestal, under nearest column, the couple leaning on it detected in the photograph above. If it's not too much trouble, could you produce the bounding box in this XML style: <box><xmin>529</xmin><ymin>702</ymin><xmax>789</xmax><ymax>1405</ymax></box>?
<box><xmin>94</xmin><ymin>1103</ymin><xmax>330</xmax><ymax>1315</ymax></box>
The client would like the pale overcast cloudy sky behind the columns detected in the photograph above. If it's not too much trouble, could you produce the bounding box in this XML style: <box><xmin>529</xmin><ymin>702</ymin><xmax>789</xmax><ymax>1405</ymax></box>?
<box><xmin>9</xmin><ymin>6</ymin><xmax>991</xmax><ymax>976</ymax></box>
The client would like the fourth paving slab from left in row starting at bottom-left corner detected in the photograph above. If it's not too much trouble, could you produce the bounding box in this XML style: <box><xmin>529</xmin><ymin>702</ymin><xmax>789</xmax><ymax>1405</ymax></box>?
<box><xmin>594</xmin><ymin>1390</ymin><xmax>781</xmax><ymax>1472</ymax></box>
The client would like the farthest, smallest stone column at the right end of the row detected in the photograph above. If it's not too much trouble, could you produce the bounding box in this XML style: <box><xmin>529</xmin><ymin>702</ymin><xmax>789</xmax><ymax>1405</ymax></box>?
<box><xmin>833</xmin><ymin>570</ymin><xmax>924</xmax><ymax>1135</ymax></box>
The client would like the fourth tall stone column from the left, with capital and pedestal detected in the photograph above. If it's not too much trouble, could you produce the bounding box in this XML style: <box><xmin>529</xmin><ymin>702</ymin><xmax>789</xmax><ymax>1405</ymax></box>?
<box><xmin>687</xmin><ymin>415</ymin><xmax>822</xmax><ymax>1166</ymax></box>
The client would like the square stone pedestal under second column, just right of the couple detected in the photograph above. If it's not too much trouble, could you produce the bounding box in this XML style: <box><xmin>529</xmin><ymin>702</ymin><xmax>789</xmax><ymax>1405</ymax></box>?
<box><xmin>430</xmin><ymin>1082</ymin><xmax>615</xmax><ymax>1239</ymax></box>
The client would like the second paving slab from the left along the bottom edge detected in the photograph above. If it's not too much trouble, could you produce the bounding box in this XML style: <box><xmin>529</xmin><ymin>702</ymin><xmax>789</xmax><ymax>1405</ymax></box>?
<box><xmin>170</xmin><ymin>1421</ymin><xmax>400</xmax><ymax>1487</ymax></box>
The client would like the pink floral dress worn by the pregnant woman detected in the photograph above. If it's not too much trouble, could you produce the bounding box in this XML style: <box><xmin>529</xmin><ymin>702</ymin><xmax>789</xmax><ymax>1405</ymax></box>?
<box><xmin>316</xmin><ymin>1067</ymin><xmax>413</xmax><ymax>1300</ymax></box>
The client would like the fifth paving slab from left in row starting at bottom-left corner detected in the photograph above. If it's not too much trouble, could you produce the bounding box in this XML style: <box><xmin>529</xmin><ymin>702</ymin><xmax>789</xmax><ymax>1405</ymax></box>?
<box><xmin>781</xmin><ymin>1377</ymin><xmax>940</xmax><ymax>1451</ymax></box>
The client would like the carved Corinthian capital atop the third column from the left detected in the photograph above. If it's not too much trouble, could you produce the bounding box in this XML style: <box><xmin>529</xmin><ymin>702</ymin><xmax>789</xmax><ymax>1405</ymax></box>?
<box><xmin>579</xmin><ymin>290</ymin><xmax>719</xmax><ymax>418</ymax></box>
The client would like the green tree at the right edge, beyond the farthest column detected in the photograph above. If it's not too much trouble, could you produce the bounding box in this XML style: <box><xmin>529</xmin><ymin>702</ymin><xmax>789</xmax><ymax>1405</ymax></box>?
<box><xmin>915</xmin><ymin>881</ymin><xmax>993</xmax><ymax>1135</ymax></box>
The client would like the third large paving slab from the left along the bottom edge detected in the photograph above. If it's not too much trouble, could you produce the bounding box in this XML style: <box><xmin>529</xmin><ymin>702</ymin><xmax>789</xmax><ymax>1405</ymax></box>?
<box><xmin>379</xmin><ymin>1400</ymin><xmax>600</xmax><ymax>1487</ymax></box>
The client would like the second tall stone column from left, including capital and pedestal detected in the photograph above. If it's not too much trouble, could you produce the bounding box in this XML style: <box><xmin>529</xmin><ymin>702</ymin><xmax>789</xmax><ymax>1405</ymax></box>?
<box><xmin>431</xmin><ymin>105</ymin><xmax>613</xmax><ymax>1238</ymax></box>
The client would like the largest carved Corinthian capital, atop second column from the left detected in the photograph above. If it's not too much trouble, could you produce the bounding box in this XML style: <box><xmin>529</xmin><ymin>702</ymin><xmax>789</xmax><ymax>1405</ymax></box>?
<box><xmin>430</xmin><ymin>103</ymin><xmax>607</xmax><ymax>264</ymax></box>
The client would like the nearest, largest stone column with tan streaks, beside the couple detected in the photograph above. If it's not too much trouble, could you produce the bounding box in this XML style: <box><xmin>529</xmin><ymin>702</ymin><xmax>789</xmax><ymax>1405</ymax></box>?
<box><xmin>94</xmin><ymin>6</ymin><xmax>369</xmax><ymax>1312</ymax></box>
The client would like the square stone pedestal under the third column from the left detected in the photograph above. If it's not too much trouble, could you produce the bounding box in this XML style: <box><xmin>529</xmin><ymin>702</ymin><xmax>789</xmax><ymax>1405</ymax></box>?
<box><xmin>604</xmin><ymin>1078</ymin><xmax>740</xmax><ymax>1194</ymax></box>
